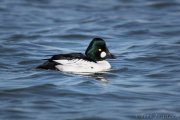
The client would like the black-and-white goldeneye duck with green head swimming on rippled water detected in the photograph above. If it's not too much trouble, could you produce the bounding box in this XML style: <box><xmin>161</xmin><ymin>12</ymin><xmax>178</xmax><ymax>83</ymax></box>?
<box><xmin>37</xmin><ymin>38</ymin><xmax>115</xmax><ymax>73</ymax></box>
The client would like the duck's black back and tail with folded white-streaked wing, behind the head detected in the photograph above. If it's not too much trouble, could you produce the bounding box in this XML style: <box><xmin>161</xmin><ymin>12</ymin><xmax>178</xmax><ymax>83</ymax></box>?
<box><xmin>37</xmin><ymin>53</ymin><xmax>88</xmax><ymax>70</ymax></box>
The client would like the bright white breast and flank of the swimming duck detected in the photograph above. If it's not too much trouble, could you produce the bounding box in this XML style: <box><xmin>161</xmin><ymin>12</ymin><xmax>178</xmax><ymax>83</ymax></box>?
<box><xmin>54</xmin><ymin>59</ymin><xmax>111</xmax><ymax>73</ymax></box>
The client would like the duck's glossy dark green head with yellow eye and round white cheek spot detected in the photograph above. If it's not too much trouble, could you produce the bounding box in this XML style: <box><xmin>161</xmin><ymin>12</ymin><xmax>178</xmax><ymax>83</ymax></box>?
<box><xmin>85</xmin><ymin>38</ymin><xmax>115</xmax><ymax>61</ymax></box>
